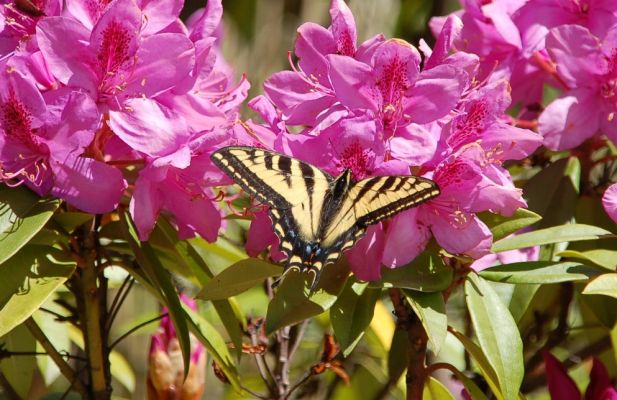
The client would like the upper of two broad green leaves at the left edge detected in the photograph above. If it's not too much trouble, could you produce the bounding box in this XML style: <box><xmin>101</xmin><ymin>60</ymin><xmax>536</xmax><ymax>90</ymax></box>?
<box><xmin>0</xmin><ymin>185</ymin><xmax>60</xmax><ymax>264</ymax></box>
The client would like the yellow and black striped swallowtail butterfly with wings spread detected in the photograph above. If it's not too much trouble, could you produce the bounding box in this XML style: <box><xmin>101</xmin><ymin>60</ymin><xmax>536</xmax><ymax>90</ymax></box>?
<box><xmin>211</xmin><ymin>146</ymin><xmax>439</xmax><ymax>292</ymax></box>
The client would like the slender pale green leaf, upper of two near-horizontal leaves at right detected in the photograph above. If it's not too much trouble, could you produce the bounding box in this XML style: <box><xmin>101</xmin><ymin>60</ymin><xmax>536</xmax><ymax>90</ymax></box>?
<box><xmin>492</xmin><ymin>224</ymin><xmax>613</xmax><ymax>253</ymax></box>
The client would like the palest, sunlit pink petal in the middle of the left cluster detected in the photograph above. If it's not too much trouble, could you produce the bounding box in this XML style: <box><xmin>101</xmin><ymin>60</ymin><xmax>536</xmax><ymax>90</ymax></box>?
<box><xmin>109</xmin><ymin>98</ymin><xmax>191</xmax><ymax>157</ymax></box>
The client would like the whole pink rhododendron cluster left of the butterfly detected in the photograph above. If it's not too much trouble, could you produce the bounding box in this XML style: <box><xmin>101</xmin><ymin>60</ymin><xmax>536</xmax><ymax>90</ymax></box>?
<box><xmin>0</xmin><ymin>0</ymin><xmax>249</xmax><ymax>241</ymax></box>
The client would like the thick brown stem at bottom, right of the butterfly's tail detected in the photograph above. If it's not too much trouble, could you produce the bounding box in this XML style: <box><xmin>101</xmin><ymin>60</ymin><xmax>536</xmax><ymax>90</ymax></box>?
<box><xmin>388</xmin><ymin>288</ymin><xmax>428</xmax><ymax>400</ymax></box>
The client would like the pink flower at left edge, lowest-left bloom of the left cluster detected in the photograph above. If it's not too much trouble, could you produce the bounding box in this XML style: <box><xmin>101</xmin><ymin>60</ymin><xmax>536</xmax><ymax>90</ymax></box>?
<box><xmin>0</xmin><ymin>66</ymin><xmax>126</xmax><ymax>213</ymax></box>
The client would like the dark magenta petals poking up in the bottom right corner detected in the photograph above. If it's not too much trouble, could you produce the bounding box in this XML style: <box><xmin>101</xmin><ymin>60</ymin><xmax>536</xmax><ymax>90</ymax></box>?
<box><xmin>542</xmin><ymin>351</ymin><xmax>617</xmax><ymax>400</ymax></box>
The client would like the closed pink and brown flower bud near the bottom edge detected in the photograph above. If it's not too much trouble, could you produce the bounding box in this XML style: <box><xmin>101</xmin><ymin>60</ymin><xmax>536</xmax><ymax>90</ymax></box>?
<box><xmin>148</xmin><ymin>294</ymin><xmax>206</xmax><ymax>400</ymax></box>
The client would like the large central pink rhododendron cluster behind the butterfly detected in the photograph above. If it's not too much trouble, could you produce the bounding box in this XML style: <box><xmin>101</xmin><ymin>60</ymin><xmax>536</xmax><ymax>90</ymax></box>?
<box><xmin>238</xmin><ymin>1</ymin><xmax>542</xmax><ymax>280</ymax></box>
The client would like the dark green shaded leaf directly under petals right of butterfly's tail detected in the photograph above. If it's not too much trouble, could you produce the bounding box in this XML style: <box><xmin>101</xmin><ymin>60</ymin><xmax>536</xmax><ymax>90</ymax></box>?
<box><xmin>371</xmin><ymin>250</ymin><xmax>453</xmax><ymax>292</ymax></box>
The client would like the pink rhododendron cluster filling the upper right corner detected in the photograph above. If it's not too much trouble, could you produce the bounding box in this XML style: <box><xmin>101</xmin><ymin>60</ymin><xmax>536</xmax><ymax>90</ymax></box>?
<box><xmin>431</xmin><ymin>0</ymin><xmax>617</xmax><ymax>150</ymax></box>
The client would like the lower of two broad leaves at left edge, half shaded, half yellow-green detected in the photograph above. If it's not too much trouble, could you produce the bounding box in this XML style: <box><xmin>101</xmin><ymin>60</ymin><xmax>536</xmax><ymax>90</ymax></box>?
<box><xmin>0</xmin><ymin>246</ymin><xmax>76</xmax><ymax>336</ymax></box>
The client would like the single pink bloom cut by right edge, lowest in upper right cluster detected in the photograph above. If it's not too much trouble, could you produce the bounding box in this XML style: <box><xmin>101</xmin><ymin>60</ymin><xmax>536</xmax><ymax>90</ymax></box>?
<box><xmin>538</xmin><ymin>25</ymin><xmax>617</xmax><ymax>150</ymax></box>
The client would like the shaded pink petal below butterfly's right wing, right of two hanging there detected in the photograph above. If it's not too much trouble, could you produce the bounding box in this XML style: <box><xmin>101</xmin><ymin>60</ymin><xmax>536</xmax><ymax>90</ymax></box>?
<box><xmin>382</xmin><ymin>208</ymin><xmax>431</xmax><ymax>268</ymax></box>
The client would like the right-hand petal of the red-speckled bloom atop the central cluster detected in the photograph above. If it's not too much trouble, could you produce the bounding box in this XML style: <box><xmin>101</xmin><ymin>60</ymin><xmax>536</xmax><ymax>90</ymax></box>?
<box><xmin>405</xmin><ymin>65</ymin><xmax>467</xmax><ymax>124</ymax></box>
